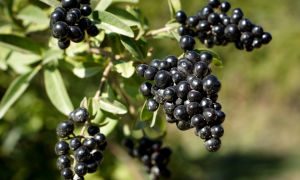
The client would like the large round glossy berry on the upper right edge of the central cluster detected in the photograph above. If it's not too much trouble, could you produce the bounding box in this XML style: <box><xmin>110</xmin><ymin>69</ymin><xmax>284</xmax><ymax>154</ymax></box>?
<box><xmin>203</xmin><ymin>75</ymin><xmax>221</xmax><ymax>94</ymax></box>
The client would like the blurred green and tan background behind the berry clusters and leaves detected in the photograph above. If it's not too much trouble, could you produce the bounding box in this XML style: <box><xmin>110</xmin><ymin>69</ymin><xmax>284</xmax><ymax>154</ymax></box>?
<box><xmin>0</xmin><ymin>0</ymin><xmax>300</xmax><ymax>180</ymax></box>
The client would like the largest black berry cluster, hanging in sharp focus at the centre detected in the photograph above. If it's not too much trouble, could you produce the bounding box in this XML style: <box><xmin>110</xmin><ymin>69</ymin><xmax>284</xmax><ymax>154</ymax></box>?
<box><xmin>136</xmin><ymin>50</ymin><xmax>225</xmax><ymax>152</ymax></box>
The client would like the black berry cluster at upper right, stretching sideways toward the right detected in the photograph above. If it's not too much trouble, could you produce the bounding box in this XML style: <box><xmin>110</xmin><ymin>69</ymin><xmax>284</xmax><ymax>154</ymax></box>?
<box><xmin>175</xmin><ymin>0</ymin><xmax>272</xmax><ymax>51</ymax></box>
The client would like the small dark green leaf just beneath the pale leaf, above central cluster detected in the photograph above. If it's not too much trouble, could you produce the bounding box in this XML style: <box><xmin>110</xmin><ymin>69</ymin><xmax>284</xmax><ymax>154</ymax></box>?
<box><xmin>121</xmin><ymin>36</ymin><xmax>143</xmax><ymax>60</ymax></box>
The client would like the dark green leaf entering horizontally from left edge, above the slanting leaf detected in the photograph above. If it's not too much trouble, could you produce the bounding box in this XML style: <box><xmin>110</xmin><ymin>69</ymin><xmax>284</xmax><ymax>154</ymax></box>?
<box><xmin>0</xmin><ymin>34</ymin><xmax>41</xmax><ymax>55</ymax></box>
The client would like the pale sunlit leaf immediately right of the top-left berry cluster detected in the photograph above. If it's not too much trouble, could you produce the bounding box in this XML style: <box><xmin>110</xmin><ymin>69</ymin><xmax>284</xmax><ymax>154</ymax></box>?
<box><xmin>97</xmin><ymin>11</ymin><xmax>134</xmax><ymax>37</ymax></box>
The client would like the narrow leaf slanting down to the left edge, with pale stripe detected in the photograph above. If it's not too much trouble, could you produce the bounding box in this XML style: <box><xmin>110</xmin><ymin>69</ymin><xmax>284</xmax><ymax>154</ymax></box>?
<box><xmin>0</xmin><ymin>66</ymin><xmax>41</xmax><ymax>119</ymax></box>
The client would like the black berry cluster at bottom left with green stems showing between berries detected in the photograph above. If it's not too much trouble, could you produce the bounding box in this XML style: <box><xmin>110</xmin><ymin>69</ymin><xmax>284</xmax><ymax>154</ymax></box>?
<box><xmin>55</xmin><ymin>108</ymin><xmax>107</xmax><ymax>180</ymax></box>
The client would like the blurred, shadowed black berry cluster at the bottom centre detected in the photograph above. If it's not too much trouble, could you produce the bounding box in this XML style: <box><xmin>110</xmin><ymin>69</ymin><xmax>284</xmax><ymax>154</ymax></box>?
<box><xmin>123</xmin><ymin>137</ymin><xmax>172</xmax><ymax>180</ymax></box>
